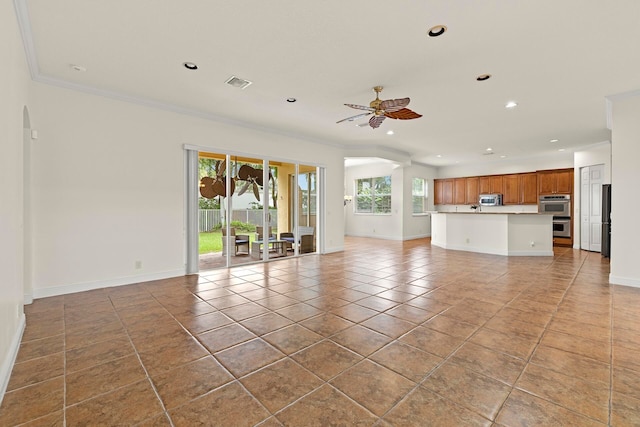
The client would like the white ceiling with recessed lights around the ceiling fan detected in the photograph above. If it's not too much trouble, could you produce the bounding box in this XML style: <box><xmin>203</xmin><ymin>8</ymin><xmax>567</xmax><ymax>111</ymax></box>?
<box><xmin>15</xmin><ymin>0</ymin><xmax>640</xmax><ymax>165</ymax></box>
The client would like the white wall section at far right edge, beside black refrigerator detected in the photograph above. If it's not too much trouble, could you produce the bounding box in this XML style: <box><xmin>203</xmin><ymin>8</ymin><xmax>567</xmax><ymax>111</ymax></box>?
<box><xmin>609</xmin><ymin>93</ymin><xmax>640</xmax><ymax>287</ymax></box>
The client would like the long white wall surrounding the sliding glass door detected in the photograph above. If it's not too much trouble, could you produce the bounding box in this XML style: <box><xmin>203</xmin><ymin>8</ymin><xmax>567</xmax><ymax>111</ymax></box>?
<box><xmin>32</xmin><ymin>84</ymin><xmax>344</xmax><ymax>297</ymax></box>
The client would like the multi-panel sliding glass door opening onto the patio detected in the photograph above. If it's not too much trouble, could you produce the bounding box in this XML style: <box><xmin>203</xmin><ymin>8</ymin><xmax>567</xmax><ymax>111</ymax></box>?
<box><xmin>188</xmin><ymin>152</ymin><xmax>318</xmax><ymax>270</ymax></box>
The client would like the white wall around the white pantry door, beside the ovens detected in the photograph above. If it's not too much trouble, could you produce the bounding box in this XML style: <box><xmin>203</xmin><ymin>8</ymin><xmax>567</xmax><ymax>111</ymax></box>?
<box><xmin>573</xmin><ymin>141</ymin><xmax>611</xmax><ymax>249</ymax></box>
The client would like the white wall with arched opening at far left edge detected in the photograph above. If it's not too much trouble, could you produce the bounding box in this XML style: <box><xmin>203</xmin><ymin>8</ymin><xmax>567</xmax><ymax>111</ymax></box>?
<box><xmin>0</xmin><ymin>1</ymin><xmax>29</xmax><ymax>402</ymax></box>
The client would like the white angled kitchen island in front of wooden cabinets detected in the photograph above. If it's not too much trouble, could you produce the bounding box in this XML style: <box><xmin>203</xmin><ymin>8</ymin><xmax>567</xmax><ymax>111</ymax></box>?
<box><xmin>431</xmin><ymin>212</ymin><xmax>553</xmax><ymax>256</ymax></box>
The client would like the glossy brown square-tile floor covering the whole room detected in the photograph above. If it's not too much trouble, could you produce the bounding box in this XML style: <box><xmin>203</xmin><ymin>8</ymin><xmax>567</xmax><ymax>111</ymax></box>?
<box><xmin>0</xmin><ymin>238</ymin><xmax>640</xmax><ymax>427</ymax></box>
